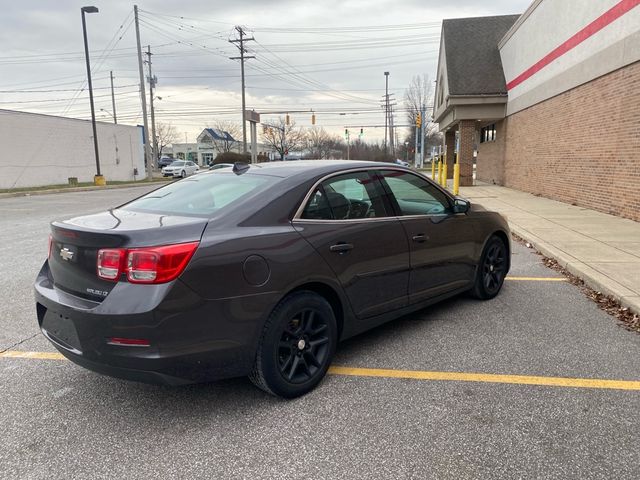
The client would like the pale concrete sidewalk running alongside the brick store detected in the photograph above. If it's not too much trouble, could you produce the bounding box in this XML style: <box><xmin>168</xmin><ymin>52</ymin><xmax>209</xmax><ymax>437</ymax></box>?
<box><xmin>460</xmin><ymin>185</ymin><xmax>640</xmax><ymax>313</ymax></box>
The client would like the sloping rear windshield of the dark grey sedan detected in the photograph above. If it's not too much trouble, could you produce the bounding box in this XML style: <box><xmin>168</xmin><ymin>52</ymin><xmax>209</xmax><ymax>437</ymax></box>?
<box><xmin>121</xmin><ymin>172</ymin><xmax>279</xmax><ymax>217</ymax></box>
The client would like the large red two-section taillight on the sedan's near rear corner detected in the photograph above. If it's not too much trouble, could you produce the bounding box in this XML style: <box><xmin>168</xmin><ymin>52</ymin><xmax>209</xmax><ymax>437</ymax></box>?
<box><xmin>98</xmin><ymin>242</ymin><xmax>198</xmax><ymax>283</ymax></box>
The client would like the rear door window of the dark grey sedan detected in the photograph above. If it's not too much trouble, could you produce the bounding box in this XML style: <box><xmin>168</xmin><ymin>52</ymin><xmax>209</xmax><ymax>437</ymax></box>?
<box><xmin>302</xmin><ymin>172</ymin><xmax>389</xmax><ymax>220</ymax></box>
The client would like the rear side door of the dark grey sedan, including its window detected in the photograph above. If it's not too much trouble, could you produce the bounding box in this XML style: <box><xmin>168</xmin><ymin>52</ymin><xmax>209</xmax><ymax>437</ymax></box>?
<box><xmin>293</xmin><ymin>171</ymin><xmax>409</xmax><ymax>318</ymax></box>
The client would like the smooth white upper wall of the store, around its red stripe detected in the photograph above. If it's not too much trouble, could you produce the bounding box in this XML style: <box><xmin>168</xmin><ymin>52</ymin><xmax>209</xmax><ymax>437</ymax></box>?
<box><xmin>499</xmin><ymin>0</ymin><xmax>640</xmax><ymax>114</ymax></box>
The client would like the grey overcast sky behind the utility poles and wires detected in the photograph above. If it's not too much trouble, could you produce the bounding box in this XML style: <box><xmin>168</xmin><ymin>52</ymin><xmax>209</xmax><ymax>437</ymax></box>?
<box><xmin>0</xmin><ymin>0</ymin><xmax>530</xmax><ymax>141</ymax></box>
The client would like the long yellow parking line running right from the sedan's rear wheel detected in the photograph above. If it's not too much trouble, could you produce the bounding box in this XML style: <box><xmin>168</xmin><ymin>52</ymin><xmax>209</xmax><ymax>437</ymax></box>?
<box><xmin>329</xmin><ymin>366</ymin><xmax>640</xmax><ymax>390</ymax></box>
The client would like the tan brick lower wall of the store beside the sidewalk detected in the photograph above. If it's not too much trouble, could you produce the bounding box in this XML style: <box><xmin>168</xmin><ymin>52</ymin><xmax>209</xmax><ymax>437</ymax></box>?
<box><xmin>504</xmin><ymin>62</ymin><xmax>640</xmax><ymax>221</ymax></box>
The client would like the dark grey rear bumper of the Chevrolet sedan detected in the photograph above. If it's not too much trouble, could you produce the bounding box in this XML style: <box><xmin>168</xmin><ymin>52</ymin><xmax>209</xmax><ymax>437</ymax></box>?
<box><xmin>35</xmin><ymin>263</ymin><xmax>277</xmax><ymax>385</ymax></box>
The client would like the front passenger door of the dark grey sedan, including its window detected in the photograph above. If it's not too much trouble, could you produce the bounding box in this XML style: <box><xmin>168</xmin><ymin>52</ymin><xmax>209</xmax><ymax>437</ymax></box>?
<box><xmin>377</xmin><ymin>169</ymin><xmax>477</xmax><ymax>304</ymax></box>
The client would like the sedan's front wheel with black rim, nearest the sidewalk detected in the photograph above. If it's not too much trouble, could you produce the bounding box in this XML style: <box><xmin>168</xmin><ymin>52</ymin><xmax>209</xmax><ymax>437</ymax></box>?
<box><xmin>471</xmin><ymin>235</ymin><xmax>509</xmax><ymax>300</ymax></box>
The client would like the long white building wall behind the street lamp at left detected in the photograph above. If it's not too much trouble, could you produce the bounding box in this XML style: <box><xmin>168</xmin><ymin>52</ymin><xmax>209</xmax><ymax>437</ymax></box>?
<box><xmin>0</xmin><ymin>110</ymin><xmax>145</xmax><ymax>188</ymax></box>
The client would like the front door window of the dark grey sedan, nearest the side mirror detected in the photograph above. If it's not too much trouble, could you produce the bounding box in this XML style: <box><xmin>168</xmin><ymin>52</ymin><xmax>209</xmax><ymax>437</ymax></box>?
<box><xmin>380</xmin><ymin>170</ymin><xmax>450</xmax><ymax>216</ymax></box>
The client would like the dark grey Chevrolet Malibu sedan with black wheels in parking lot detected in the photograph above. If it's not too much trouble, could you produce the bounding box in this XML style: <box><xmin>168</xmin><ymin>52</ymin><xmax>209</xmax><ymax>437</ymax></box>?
<box><xmin>35</xmin><ymin>161</ymin><xmax>510</xmax><ymax>398</ymax></box>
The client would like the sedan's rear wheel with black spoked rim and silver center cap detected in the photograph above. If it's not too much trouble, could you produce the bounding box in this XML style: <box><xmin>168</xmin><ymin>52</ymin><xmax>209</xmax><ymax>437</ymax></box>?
<box><xmin>249</xmin><ymin>291</ymin><xmax>338</xmax><ymax>398</ymax></box>
